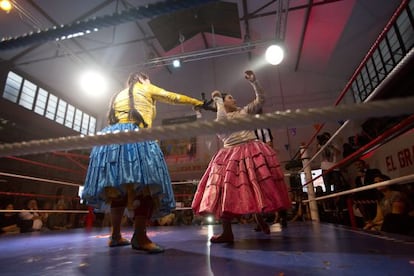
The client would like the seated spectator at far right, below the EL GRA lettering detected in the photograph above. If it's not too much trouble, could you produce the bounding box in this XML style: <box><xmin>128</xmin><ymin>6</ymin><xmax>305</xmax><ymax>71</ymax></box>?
<box><xmin>364</xmin><ymin>174</ymin><xmax>406</xmax><ymax>231</ymax></box>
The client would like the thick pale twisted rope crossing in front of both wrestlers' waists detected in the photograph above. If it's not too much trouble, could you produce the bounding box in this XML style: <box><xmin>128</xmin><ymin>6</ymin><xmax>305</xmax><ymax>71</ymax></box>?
<box><xmin>0</xmin><ymin>97</ymin><xmax>414</xmax><ymax>157</ymax></box>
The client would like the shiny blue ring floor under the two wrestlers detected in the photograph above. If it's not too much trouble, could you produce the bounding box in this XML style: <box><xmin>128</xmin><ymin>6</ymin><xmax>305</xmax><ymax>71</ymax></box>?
<box><xmin>0</xmin><ymin>222</ymin><xmax>414</xmax><ymax>276</ymax></box>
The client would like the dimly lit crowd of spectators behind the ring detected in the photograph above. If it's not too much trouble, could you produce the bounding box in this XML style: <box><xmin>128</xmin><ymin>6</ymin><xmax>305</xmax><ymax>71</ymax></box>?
<box><xmin>0</xmin><ymin>160</ymin><xmax>414</xmax><ymax>238</ymax></box>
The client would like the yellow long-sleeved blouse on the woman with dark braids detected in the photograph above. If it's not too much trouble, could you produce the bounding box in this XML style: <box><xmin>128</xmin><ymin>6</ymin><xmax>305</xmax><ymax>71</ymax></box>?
<box><xmin>114</xmin><ymin>82</ymin><xmax>203</xmax><ymax>127</ymax></box>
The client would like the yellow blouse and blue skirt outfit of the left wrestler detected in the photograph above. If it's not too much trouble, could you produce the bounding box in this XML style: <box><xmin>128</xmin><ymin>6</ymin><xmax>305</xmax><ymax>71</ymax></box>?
<box><xmin>82</xmin><ymin>83</ymin><xmax>203</xmax><ymax>218</ymax></box>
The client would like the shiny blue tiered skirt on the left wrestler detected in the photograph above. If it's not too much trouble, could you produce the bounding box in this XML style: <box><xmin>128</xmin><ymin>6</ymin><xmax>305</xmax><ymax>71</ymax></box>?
<box><xmin>82</xmin><ymin>123</ymin><xmax>175</xmax><ymax>218</ymax></box>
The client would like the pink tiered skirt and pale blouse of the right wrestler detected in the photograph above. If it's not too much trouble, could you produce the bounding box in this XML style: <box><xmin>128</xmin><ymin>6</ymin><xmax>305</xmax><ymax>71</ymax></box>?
<box><xmin>192</xmin><ymin>82</ymin><xmax>291</xmax><ymax>218</ymax></box>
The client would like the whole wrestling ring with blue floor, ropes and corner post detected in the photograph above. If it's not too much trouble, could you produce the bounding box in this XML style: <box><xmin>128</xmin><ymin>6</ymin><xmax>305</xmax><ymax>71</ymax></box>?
<box><xmin>0</xmin><ymin>1</ymin><xmax>414</xmax><ymax>276</ymax></box>
